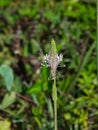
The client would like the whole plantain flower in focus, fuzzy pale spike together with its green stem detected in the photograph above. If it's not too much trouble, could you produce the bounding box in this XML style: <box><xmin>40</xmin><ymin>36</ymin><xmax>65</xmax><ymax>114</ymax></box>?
<box><xmin>44</xmin><ymin>39</ymin><xmax>63</xmax><ymax>130</ymax></box>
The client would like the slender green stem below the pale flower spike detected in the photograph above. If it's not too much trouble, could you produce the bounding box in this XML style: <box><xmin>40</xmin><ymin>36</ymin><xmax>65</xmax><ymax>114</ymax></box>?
<box><xmin>52</xmin><ymin>78</ymin><xmax>57</xmax><ymax>130</ymax></box>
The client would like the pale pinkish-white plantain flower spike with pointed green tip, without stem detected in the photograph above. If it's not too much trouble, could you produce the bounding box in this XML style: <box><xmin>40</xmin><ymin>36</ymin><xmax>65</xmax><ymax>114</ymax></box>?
<box><xmin>44</xmin><ymin>39</ymin><xmax>63</xmax><ymax>79</ymax></box>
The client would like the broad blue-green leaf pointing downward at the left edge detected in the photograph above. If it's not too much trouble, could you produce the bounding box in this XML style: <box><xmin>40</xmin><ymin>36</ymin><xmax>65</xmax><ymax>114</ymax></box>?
<box><xmin>0</xmin><ymin>64</ymin><xmax>14</xmax><ymax>91</ymax></box>
